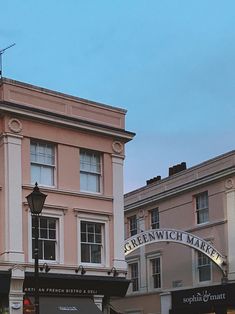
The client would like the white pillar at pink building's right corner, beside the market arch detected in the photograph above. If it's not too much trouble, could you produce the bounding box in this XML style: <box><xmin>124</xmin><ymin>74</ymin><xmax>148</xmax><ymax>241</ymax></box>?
<box><xmin>112</xmin><ymin>155</ymin><xmax>127</xmax><ymax>271</ymax></box>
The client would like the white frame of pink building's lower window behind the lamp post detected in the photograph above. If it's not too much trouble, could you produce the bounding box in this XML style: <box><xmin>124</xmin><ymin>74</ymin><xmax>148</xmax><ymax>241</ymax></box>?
<box><xmin>28</xmin><ymin>208</ymin><xmax>64</xmax><ymax>264</ymax></box>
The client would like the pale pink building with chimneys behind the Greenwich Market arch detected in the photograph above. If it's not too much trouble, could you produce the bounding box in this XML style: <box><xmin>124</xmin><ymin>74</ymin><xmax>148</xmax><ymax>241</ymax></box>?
<box><xmin>113</xmin><ymin>151</ymin><xmax>235</xmax><ymax>314</ymax></box>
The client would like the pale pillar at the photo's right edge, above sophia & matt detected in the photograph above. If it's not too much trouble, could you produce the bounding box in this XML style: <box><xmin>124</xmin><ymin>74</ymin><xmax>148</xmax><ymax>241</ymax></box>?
<box><xmin>227</xmin><ymin>189</ymin><xmax>235</xmax><ymax>280</ymax></box>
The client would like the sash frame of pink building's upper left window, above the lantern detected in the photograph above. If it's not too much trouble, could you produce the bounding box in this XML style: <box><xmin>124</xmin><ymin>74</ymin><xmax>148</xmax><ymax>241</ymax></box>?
<box><xmin>30</xmin><ymin>139</ymin><xmax>57</xmax><ymax>187</ymax></box>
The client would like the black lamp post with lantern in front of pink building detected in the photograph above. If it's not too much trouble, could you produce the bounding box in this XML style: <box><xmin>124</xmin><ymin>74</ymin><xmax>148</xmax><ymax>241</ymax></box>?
<box><xmin>26</xmin><ymin>182</ymin><xmax>47</xmax><ymax>314</ymax></box>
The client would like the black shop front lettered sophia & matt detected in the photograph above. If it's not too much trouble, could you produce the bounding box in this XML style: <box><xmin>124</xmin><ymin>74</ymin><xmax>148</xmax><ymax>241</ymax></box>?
<box><xmin>170</xmin><ymin>283</ymin><xmax>235</xmax><ymax>314</ymax></box>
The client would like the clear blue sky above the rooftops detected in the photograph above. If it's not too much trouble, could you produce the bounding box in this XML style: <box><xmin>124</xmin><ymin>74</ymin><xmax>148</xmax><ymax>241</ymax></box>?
<box><xmin>0</xmin><ymin>0</ymin><xmax>235</xmax><ymax>192</ymax></box>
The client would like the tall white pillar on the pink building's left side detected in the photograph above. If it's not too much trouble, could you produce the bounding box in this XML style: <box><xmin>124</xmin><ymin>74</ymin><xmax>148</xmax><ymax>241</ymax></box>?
<box><xmin>1</xmin><ymin>134</ymin><xmax>24</xmax><ymax>262</ymax></box>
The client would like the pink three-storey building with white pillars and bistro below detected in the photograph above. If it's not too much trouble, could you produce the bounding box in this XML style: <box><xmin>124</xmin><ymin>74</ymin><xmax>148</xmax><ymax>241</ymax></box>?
<box><xmin>0</xmin><ymin>78</ymin><xmax>134</xmax><ymax>314</ymax></box>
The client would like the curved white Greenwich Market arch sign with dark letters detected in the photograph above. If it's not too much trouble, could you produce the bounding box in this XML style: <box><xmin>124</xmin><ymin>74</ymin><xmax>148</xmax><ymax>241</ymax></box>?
<box><xmin>124</xmin><ymin>229</ymin><xmax>226</xmax><ymax>274</ymax></box>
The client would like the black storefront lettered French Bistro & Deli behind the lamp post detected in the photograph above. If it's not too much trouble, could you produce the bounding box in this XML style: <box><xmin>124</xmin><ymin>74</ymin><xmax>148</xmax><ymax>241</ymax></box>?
<box><xmin>24</xmin><ymin>272</ymin><xmax>130</xmax><ymax>314</ymax></box>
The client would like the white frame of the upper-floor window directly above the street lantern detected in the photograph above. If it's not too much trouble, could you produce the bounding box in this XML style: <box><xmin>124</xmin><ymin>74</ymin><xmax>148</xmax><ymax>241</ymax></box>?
<box><xmin>30</xmin><ymin>139</ymin><xmax>56</xmax><ymax>187</ymax></box>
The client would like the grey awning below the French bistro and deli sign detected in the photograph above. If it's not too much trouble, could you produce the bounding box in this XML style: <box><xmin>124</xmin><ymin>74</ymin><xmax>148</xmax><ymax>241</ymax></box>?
<box><xmin>40</xmin><ymin>297</ymin><xmax>102</xmax><ymax>314</ymax></box>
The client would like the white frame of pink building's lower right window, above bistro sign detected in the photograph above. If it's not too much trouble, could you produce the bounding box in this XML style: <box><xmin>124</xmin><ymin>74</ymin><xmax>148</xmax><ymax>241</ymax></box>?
<box><xmin>76</xmin><ymin>209</ymin><xmax>110</xmax><ymax>268</ymax></box>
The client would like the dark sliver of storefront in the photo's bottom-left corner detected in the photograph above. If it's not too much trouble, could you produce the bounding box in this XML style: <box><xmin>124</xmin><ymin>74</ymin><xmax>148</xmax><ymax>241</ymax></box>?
<box><xmin>0</xmin><ymin>271</ymin><xmax>11</xmax><ymax>314</ymax></box>
